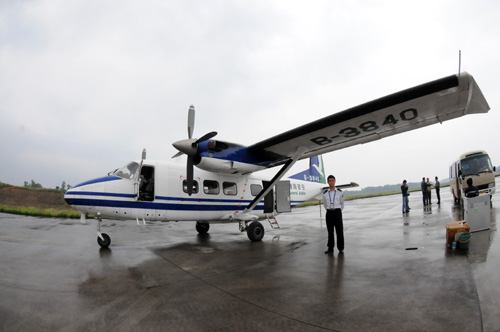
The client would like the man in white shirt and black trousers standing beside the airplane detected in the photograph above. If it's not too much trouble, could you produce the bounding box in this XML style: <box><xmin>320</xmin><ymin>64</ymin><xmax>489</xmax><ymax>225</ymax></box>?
<box><xmin>323</xmin><ymin>175</ymin><xmax>344</xmax><ymax>255</ymax></box>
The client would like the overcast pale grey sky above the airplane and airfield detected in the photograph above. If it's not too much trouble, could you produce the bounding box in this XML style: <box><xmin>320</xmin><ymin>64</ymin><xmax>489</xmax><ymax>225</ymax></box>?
<box><xmin>0</xmin><ymin>0</ymin><xmax>500</xmax><ymax>188</ymax></box>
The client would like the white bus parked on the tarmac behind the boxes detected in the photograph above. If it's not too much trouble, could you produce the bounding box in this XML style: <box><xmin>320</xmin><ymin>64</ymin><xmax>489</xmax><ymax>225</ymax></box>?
<box><xmin>450</xmin><ymin>150</ymin><xmax>496</xmax><ymax>203</ymax></box>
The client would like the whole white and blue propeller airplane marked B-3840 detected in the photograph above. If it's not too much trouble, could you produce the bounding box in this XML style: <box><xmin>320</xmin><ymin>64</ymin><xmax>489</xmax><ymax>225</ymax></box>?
<box><xmin>64</xmin><ymin>73</ymin><xmax>490</xmax><ymax>247</ymax></box>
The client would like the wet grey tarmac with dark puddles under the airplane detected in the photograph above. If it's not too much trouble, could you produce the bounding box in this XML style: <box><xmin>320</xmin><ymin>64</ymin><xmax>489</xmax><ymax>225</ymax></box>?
<box><xmin>0</xmin><ymin>183</ymin><xmax>500</xmax><ymax>332</ymax></box>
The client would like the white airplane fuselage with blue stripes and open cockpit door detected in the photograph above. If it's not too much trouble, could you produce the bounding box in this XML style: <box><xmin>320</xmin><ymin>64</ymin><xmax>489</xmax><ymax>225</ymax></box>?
<box><xmin>65</xmin><ymin>160</ymin><xmax>324</xmax><ymax>222</ymax></box>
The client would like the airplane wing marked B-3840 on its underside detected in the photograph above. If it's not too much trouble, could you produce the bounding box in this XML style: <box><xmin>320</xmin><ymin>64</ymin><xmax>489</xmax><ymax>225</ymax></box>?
<box><xmin>248</xmin><ymin>73</ymin><xmax>490</xmax><ymax>159</ymax></box>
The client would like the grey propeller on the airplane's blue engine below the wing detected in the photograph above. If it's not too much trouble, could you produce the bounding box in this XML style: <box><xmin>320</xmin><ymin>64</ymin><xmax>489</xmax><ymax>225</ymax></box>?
<box><xmin>172</xmin><ymin>105</ymin><xmax>217</xmax><ymax>196</ymax></box>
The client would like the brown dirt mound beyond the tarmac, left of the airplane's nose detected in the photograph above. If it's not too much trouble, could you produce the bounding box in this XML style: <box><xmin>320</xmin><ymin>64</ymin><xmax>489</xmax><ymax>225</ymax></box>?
<box><xmin>0</xmin><ymin>186</ymin><xmax>69</xmax><ymax>208</ymax></box>
